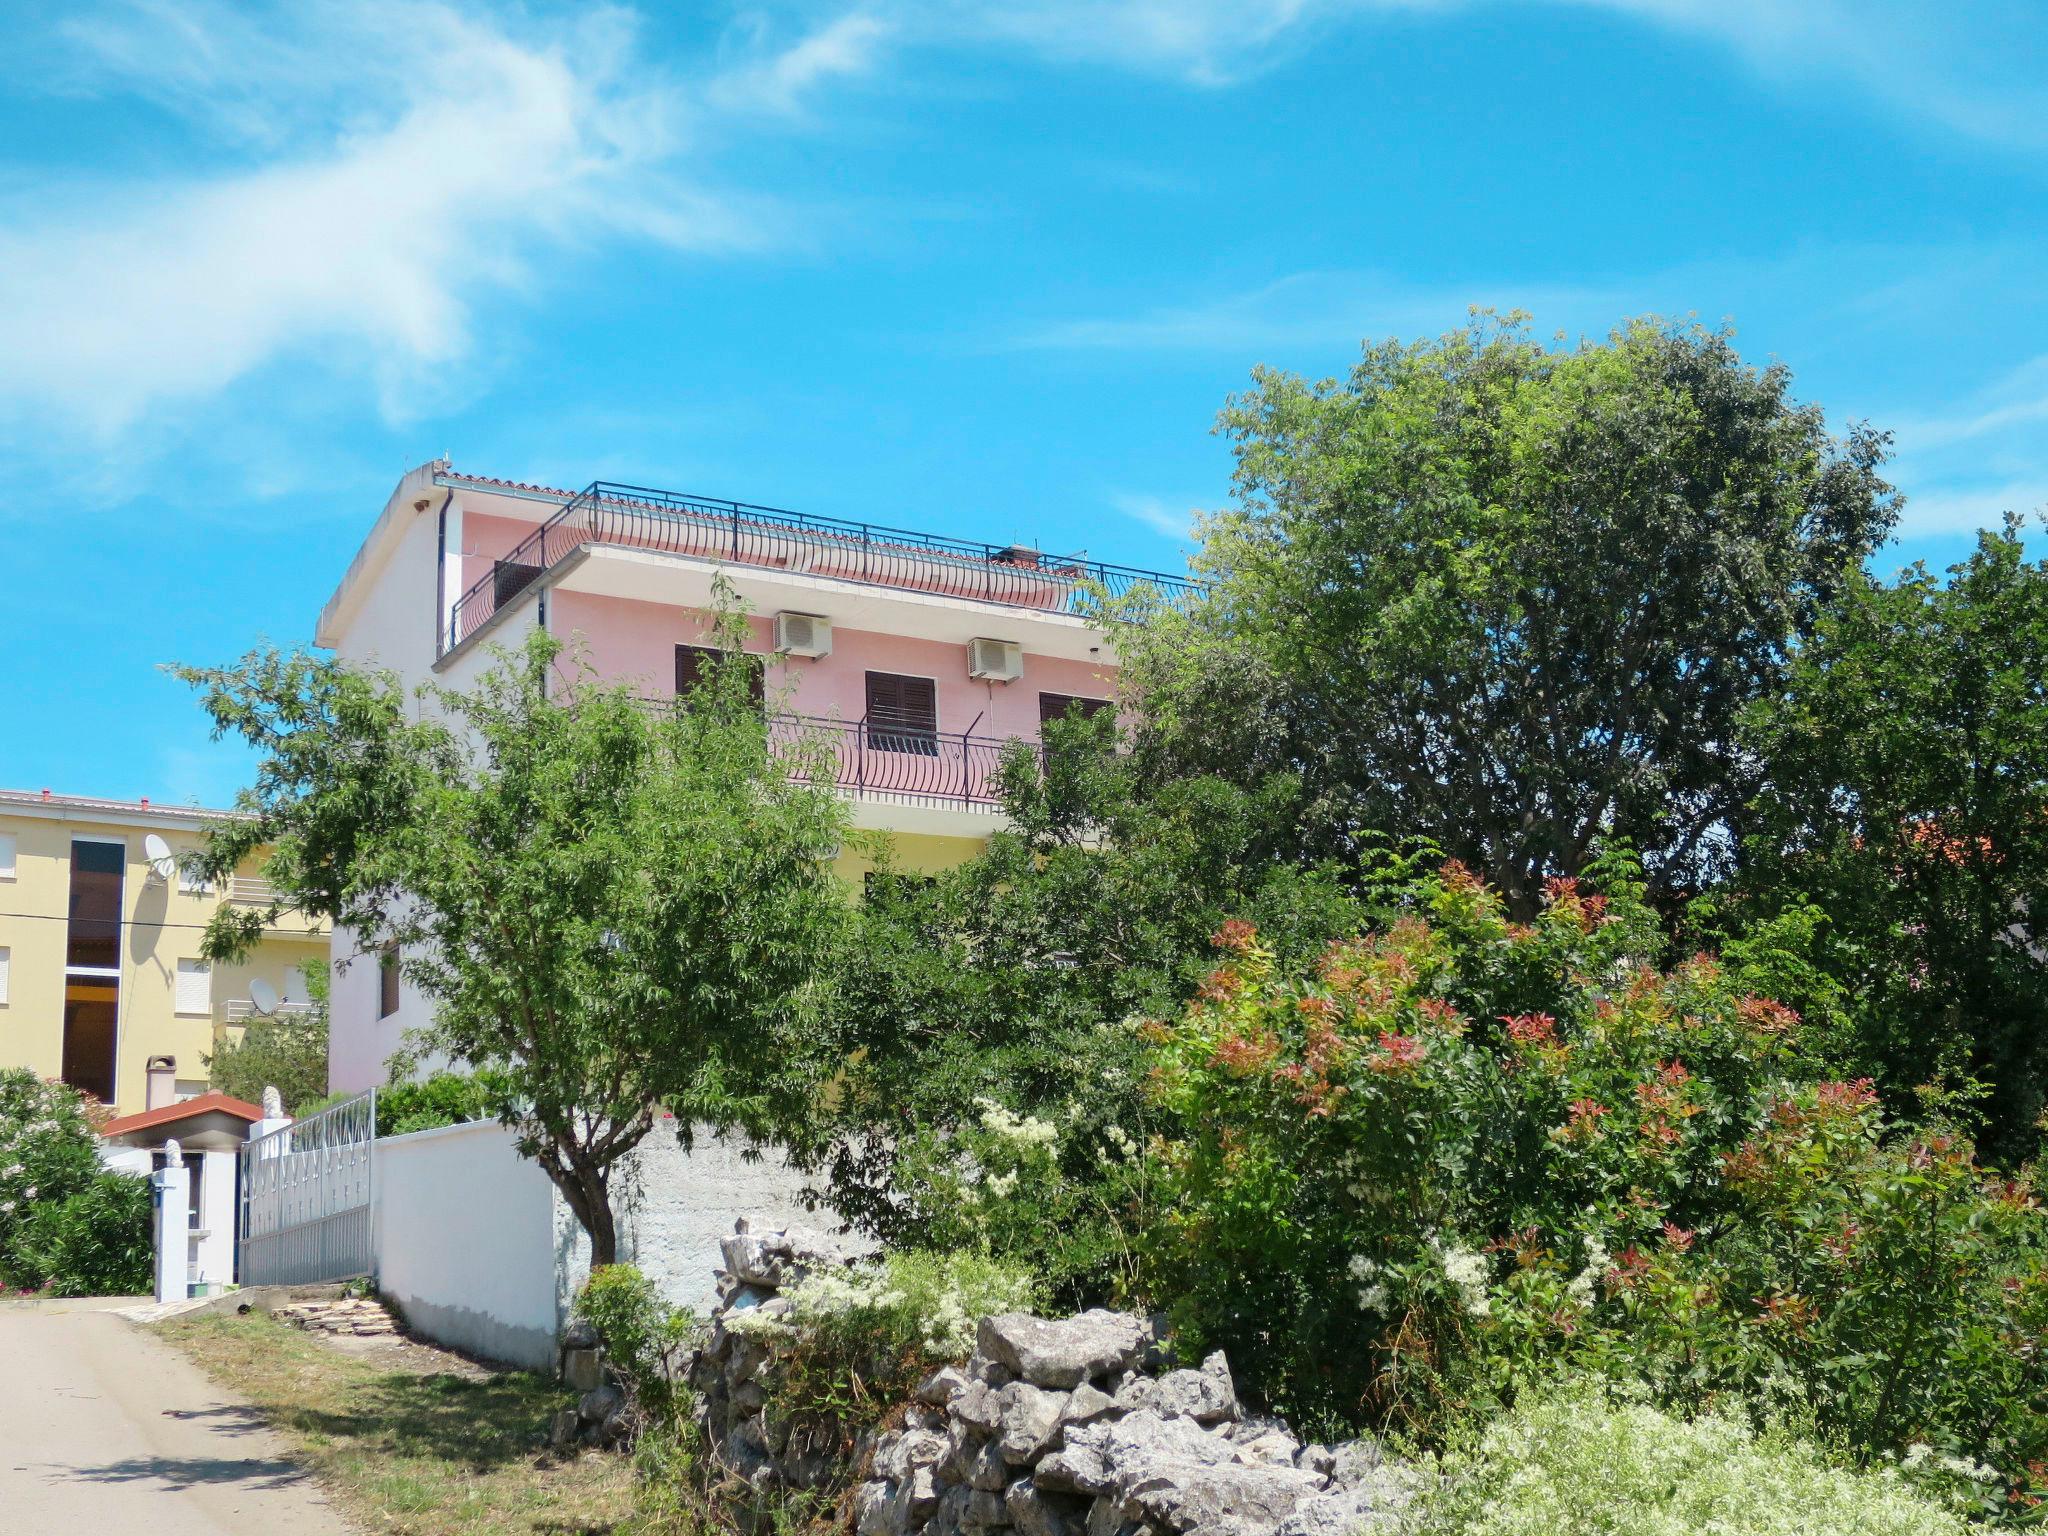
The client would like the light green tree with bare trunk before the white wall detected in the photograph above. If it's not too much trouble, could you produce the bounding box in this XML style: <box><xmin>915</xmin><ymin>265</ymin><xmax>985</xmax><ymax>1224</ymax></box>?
<box><xmin>184</xmin><ymin>618</ymin><xmax>844</xmax><ymax>1264</ymax></box>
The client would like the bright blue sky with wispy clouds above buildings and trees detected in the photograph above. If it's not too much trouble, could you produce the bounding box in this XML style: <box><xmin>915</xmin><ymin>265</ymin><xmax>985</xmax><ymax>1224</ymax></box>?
<box><xmin>0</xmin><ymin>0</ymin><xmax>2048</xmax><ymax>803</ymax></box>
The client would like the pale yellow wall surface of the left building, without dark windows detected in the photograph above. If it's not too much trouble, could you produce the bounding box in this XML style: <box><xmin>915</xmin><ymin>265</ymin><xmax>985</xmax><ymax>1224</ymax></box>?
<box><xmin>0</xmin><ymin>805</ymin><xmax>328</xmax><ymax>1114</ymax></box>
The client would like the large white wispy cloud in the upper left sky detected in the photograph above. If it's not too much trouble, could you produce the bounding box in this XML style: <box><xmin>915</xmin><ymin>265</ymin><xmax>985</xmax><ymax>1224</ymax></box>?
<box><xmin>0</xmin><ymin>0</ymin><xmax>879</xmax><ymax>442</ymax></box>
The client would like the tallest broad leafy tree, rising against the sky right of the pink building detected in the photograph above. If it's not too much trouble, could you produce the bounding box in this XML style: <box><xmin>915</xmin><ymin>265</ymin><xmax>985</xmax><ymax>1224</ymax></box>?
<box><xmin>1118</xmin><ymin>317</ymin><xmax>1894</xmax><ymax>915</ymax></box>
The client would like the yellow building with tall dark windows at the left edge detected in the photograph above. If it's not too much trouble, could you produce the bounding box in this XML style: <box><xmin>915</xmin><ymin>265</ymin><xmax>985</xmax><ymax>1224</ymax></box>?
<box><xmin>0</xmin><ymin>791</ymin><xmax>328</xmax><ymax>1114</ymax></box>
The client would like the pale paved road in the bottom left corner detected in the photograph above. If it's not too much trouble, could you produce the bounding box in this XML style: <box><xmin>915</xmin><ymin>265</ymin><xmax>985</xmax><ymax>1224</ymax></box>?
<box><xmin>0</xmin><ymin>1303</ymin><xmax>350</xmax><ymax>1536</ymax></box>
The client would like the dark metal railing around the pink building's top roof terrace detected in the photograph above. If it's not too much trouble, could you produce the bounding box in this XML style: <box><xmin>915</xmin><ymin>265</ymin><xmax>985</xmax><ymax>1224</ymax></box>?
<box><xmin>442</xmin><ymin>481</ymin><xmax>1202</xmax><ymax>649</ymax></box>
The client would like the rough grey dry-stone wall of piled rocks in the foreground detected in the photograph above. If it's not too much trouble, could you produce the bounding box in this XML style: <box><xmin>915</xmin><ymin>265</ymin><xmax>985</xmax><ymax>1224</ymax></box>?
<box><xmin>690</xmin><ymin>1223</ymin><xmax>1407</xmax><ymax>1536</ymax></box>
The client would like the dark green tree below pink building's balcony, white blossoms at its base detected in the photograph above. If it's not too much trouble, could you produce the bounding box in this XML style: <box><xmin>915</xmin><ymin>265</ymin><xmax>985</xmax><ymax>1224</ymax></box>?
<box><xmin>807</xmin><ymin>715</ymin><xmax>1360</xmax><ymax>1305</ymax></box>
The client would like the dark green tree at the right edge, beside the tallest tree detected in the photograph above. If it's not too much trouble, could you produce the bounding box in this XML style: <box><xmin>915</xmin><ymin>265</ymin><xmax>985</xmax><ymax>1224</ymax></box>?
<box><xmin>1726</xmin><ymin>522</ymin><xmax>2048</xmax><ymax>1157</ymax></box>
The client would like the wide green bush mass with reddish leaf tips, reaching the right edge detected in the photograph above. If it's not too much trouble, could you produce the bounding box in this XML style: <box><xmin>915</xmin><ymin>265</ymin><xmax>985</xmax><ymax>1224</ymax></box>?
<box><xmin>1147</xmin><ymin>864</ymin><xmax>2048</xmax><ymax>1513</ymax></box>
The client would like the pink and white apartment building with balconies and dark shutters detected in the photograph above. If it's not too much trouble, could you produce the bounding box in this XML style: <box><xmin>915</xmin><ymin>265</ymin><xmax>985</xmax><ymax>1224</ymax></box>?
<box><xmin>315</xmin><ymin>461</ymin><xmax>1192</xmax><ymax>1092</ymax></box>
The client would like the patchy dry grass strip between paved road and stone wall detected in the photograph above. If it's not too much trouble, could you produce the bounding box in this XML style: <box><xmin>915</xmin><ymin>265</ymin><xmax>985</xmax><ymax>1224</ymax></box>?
<box><xmin>158</xmin><ymin>1313</ymin><xmax>633</xmax><ymax>1536</ymax></box>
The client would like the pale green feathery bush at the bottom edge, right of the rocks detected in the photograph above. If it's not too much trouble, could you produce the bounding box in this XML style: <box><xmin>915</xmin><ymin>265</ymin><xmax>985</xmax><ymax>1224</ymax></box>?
<box><xmin>1409</xmin><ymin>1393</ymin><xmax>1968</xmax><ymax>1536</ymax></box>
